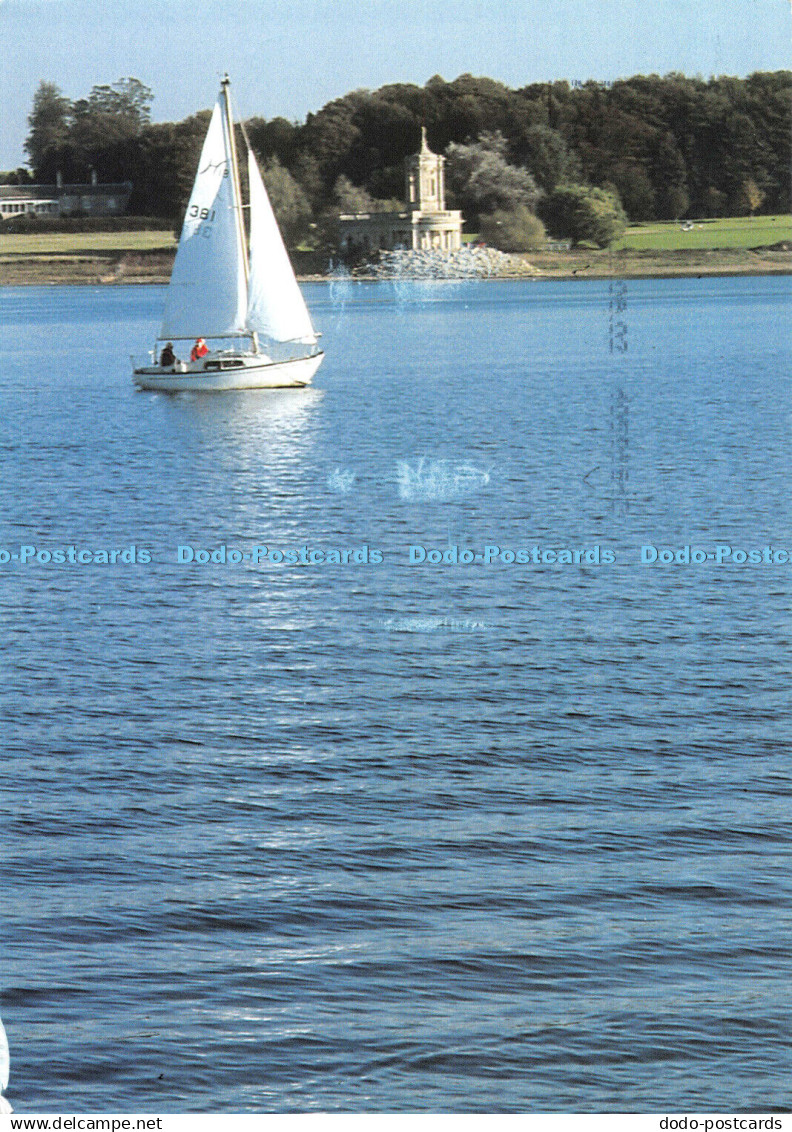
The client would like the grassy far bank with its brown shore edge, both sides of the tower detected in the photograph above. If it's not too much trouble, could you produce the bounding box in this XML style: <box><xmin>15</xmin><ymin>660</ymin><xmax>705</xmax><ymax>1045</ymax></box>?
<box><xmin>0</xmin><ymin>216</ymin><xmax>792</xmax><ymax>286</ymax></box>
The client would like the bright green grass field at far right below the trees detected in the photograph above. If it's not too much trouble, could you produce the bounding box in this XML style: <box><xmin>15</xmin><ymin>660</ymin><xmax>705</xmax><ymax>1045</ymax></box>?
<box><xmin>613</xmin><ymin>215</ymin><xmax>792</xmax><ymax>251</ymax></box>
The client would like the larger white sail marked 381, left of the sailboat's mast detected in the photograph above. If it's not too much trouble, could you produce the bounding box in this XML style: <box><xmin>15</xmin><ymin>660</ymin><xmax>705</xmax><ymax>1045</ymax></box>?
<box><xmin>160</xmin><ymin>103</ymin><xmax>248</xmax><ymax>338</ymax></box>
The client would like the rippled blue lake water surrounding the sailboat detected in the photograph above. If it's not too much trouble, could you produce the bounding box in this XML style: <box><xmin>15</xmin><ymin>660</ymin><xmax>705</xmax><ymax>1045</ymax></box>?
<box><xmin>0</xmin><ymin>277</ymin><xmax>792</xmax><ymax>1113</ymax></box>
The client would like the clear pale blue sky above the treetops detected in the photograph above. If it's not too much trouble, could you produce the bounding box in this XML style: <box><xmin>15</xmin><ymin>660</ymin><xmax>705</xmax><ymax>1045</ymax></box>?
<box><xmin>0</xmin><ymin>0</ymin><xmax>792</xmax><ymax>170</ymax></box>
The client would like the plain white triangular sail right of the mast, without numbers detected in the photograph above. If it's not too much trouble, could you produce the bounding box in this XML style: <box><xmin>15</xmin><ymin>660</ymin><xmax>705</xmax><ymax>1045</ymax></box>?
<box><xmin>248</xmin><ymin>151</ymin><xmax>316</xmax><ymax>343</ymax></box>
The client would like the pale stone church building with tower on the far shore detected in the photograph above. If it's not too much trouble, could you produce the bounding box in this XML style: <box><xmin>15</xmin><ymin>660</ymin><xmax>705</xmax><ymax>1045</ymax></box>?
<box><xmin>338</xmin><ymin>127</ymin><xmax>462</xmax><ymax>255</ymax></box>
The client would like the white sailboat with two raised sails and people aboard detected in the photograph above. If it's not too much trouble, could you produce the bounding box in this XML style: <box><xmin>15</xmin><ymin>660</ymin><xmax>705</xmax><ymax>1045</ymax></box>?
<box><xmin>132</xmin><ymin>76</ymin><xmax>324</xmax><ymax>393</ymax></box>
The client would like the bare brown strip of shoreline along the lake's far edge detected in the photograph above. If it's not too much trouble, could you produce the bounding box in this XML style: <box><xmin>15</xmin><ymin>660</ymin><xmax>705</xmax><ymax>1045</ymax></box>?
<box><xmin>0</xmin><ymin>248</ymin><xmax>792</xmax><ymax>286</ymax></box>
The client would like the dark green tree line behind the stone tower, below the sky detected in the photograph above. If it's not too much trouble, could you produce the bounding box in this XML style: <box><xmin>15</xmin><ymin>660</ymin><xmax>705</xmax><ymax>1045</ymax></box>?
<box><xmin>12</xmin><ymin>71</ymin><xmax>792</xmax><ymax>245</ymax></box>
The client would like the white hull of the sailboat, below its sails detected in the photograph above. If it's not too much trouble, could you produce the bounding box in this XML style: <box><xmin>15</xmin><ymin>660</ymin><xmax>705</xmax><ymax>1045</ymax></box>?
<box><xmin>132</xmin><ymin>352</ymin><xmax>325</xmax><ymax>393</ymax></box>
